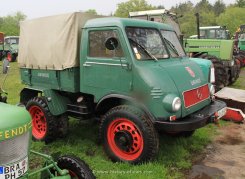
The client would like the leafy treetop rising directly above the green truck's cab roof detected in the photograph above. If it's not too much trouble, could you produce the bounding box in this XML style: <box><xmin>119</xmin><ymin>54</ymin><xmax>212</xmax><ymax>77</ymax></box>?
<box><xmin>115</xmin><ymin>0</ymin><xmax>156</xmax><ymax>17</ymax></box>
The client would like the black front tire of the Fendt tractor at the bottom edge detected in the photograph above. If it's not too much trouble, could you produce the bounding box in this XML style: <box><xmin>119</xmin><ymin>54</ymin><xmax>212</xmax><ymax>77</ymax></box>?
<box><xmin>57</xmin><ymin>156</ymin><xmax>95</xmax><ymax>179</ymax></box>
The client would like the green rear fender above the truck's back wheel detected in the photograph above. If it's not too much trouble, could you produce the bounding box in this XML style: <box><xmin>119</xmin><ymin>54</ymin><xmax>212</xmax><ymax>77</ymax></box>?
<box><xmin>20</xmin><ymin>87</ymin><xmax>69</xmax><ymax>116</ymax></box>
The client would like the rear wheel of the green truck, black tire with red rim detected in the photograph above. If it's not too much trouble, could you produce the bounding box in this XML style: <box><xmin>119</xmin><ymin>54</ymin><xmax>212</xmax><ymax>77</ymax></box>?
<box><xmin>26</xmin><ymin>97</ymin><xmax>58</xmax><ymax>143</ymax></box>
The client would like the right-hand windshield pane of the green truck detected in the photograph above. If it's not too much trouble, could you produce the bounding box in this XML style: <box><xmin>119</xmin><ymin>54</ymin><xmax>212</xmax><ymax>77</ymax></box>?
<box><xmin>161</xmin><ymin>30</ymin><xmax>185</xmax><ymax>57</ymax></box>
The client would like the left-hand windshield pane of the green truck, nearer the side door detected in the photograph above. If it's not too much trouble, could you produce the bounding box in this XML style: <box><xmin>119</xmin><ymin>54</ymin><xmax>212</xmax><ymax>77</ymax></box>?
<box><xmin>126</xmin><ymin>27</ymin><xmax>169</xmax><ymax>60</ymax></box>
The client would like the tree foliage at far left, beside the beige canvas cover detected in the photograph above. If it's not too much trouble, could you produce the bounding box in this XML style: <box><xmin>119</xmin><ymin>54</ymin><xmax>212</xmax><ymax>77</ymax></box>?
<box><xmin>0</xmin><ymin>12</ymin><xmax>26</xmax><ymax>36</ymax></box>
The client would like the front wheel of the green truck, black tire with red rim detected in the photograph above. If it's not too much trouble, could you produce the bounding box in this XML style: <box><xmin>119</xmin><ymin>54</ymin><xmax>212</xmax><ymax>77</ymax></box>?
<box><xmin>99</xmin><ymin>105</ymin><xmax>159</xmax><ymax>164</ymax></box>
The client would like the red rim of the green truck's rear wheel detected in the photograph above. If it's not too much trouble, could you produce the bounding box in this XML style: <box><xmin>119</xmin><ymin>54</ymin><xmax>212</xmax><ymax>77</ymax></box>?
<box><xmin>29</xmin><ymin>106</ymin><xmax>47</xmax><ymax>139</ymax></box>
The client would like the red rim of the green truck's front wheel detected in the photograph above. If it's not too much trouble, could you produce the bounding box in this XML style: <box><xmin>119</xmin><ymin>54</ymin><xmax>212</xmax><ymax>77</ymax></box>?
<box><xmin>107</xmin><ymin>118</ymin><xmax>144</xmax><ymax>161</ymax></box>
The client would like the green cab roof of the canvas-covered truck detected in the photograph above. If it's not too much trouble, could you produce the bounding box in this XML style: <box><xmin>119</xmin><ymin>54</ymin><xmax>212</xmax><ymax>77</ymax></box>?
<box><xmin>84</xmin><ymin>17</ymin><xmax>173</xmax><ymax>31</ymax></box>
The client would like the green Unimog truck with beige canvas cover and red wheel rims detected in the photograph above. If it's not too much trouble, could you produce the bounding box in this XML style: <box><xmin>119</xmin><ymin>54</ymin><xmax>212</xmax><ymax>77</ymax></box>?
<box><xmin>18</xmin><ymin>13</ymin><xmax>226</xmax><ymax>164</ymax></box>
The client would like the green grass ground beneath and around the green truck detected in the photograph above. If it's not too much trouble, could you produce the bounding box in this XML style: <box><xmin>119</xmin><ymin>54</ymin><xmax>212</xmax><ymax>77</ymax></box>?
<box><xmin>0</xmin><ymin>63</ymin><xmax>222</xmax><ymax>179</ymax></box>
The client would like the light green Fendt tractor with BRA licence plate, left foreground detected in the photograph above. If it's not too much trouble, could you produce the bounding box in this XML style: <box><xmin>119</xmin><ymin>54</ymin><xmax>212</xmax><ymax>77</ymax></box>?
<box><xmin>0</xmin><ymin>64</ymin><xmax>95</xmax><ymax>179</ymax></box>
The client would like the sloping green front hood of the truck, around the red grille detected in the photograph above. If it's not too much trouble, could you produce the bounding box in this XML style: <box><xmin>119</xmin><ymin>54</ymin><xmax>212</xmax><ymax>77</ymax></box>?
<box><xmin>135</xmin><ymin>58</ymin><xmax>209</xmax><ymax>117</ymax></box>
